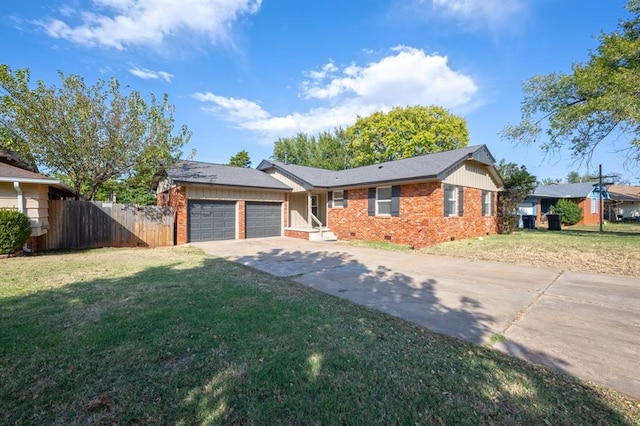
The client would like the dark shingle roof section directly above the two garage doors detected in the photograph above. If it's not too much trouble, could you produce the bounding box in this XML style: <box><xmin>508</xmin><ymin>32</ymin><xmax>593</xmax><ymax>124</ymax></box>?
<box><xmin>167</xmin><ymin>160</ymin><xmax>291</xmax><ymax>191</ymax></box>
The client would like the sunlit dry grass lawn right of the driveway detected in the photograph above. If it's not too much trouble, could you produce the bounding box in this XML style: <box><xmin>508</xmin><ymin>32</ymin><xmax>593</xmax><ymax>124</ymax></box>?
<box><xmin>420</xmin><ymin>223</ymin><xmax>640</xmax><ymax>277</ymax></box>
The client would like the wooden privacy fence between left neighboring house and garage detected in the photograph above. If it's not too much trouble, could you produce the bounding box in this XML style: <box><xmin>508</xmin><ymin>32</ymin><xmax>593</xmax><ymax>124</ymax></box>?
<box><xmin>38</xmin><ymin>200</ymin><xmax>174</xmax><ymax>250</ymax></box>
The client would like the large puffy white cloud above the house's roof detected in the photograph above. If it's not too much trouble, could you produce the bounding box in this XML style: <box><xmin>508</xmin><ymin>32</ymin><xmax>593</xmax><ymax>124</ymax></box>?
<box><xmin>194</xmin><ymin>46</ymin><xmax>478</xmax><ymax>141</ymax></box>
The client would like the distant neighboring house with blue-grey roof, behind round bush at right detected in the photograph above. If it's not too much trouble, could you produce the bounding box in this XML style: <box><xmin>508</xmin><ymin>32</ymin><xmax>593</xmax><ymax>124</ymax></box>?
<box><xmin>520</xmin><ymin>182</ymin><xmax>609</xmax><ymax>225</ymax></box>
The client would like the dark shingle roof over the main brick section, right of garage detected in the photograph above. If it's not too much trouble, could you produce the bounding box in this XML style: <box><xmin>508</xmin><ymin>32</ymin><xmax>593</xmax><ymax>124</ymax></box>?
<box><xmin>258</xmin><ymin>145</ymin><xmax>494</xmax><ymax>188</ymax></box>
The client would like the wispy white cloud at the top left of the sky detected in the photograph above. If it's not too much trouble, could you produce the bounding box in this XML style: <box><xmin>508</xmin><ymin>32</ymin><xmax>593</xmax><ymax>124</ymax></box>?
<box><xmin>37</xmin><ymin>0</ymin><xmax>262</xmax><ymax>50</ymax></box>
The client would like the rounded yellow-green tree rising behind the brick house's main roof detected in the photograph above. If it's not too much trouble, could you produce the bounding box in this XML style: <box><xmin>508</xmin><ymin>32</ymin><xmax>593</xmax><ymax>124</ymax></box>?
<box><xmin>346</xmin><ymin>106</ymin><xmax>469</xmax><ymax>167</ymax></box>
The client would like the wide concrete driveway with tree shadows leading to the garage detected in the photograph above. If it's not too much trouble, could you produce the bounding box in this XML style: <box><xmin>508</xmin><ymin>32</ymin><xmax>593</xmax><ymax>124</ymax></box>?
<box><xmin>192</xmin><ymin>237</ymin><xmax>640</xmax><ymax>397</ymax></box>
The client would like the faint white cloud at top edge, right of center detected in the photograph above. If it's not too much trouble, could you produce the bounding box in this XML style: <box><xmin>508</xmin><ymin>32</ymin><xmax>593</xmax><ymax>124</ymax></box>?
<box><xmin>410</xmin><ymin>0</ymin><xmax>527</xmax><ymax>32</ymax></box>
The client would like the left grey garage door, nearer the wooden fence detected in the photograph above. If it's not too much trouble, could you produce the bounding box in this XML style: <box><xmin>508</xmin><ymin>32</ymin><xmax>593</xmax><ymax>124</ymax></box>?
<box><xmin>188</xmin><ymin>200</ymin><xmax>236</xmax><ymax>242</ymax></box>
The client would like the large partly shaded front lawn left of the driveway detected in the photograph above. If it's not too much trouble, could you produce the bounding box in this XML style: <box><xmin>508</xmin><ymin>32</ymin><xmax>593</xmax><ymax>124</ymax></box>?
<box><xmin>0</xmin><ymin>247</ymin><xmax>640</xmax><ymax>425</ymax></box>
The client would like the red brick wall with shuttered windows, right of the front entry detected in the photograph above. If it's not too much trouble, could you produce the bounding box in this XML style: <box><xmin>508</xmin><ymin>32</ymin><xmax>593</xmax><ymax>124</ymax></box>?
<box><xmin>329</xmin><ymin>182</ymin><xmax>497</xmax><ymax>248</ymax></box>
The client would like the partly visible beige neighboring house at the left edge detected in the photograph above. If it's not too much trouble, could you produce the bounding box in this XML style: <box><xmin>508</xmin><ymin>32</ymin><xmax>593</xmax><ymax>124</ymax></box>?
<box><xmin>0</xmin><ymin>154</ymin><xmax>71</xmax><ymax>248</ymax></box>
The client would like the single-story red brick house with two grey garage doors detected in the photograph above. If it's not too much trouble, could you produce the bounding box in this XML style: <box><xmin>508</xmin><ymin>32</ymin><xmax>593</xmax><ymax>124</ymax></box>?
<box><xmin>158</xmin><ymin>145</ymin><xmax>503</xmax><ymax>248</ymax></box>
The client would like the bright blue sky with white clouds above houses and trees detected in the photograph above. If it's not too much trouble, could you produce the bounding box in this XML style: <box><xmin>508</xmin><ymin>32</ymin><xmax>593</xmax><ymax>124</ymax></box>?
<box><xmin>0</xmin><ymin>0</ymin><xmax>640</xmax><ymax>184</ymax></box>
